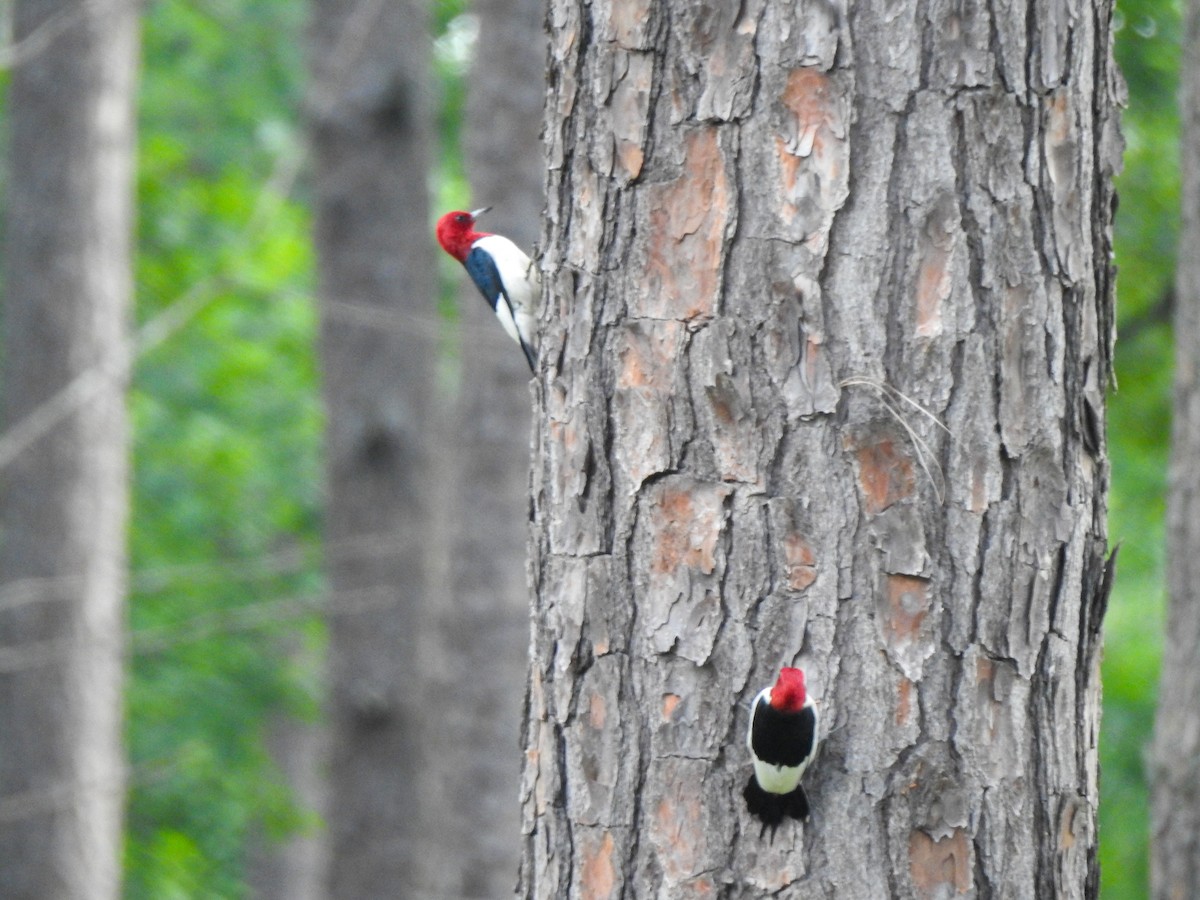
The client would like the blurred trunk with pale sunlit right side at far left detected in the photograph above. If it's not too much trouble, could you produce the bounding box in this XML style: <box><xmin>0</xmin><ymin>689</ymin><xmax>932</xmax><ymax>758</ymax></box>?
<box><xmin>0</xmin><ymin>0</ymin><xmax>138</xmax><ymax>900</ymax></box>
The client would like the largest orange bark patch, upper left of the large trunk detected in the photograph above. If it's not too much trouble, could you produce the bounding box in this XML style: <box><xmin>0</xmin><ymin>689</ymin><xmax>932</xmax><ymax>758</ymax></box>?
<box><xmin>631</xmin><ymin>128</ymin><xmax>730</xmax><ymax>322</ymax></box>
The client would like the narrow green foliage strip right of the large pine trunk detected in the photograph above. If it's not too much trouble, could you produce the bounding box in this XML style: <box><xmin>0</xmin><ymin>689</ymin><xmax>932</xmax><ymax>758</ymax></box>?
<box><xmin>1100</xmin><ymin>0</ymin><xmax>1181</xmax><ymax>900</ymax></box>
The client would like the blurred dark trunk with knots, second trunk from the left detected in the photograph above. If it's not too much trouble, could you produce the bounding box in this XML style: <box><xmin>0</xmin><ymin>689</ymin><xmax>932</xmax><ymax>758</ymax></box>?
<box><xmin>308</xmin><ymin>0</ymin><xmax>437</xmax><ymax>900</ymax></box>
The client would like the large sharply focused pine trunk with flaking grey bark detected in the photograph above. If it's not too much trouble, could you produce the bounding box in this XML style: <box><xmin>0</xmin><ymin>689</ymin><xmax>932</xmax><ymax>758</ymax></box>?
<box><xmin>522</xmin><ymin>0</ymin><xmax>1120</xmax><ymax>900</ymax></box>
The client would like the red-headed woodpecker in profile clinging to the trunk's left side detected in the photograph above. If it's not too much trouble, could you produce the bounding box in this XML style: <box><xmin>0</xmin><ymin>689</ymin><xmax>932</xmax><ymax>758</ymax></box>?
<box><xmin>438</xmin><ymin>206</ymin><xmax>541</xmax><ymax>372</ymax></box>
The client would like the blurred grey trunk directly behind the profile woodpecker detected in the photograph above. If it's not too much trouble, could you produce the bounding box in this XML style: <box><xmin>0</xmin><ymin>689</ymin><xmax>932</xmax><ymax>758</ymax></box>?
<box><xmin>412</xmin><ymin>0</ymin><xmax>546</xmax><ymax>898</ymax></box>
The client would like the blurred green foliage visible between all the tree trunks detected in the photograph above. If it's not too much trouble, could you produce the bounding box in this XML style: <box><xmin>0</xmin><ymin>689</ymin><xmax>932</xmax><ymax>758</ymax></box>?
<box><xmin>0</xmin><ymin>0</ymin><xmax>1181</xmax><ymax>898</ymax></box>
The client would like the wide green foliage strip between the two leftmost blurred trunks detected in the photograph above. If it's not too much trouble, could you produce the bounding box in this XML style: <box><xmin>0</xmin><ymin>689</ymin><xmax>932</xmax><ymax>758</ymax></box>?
<box><xmin>126</xmin><ymin>0</ymin><xmax>322</xmax><ymax>899</ymax></box>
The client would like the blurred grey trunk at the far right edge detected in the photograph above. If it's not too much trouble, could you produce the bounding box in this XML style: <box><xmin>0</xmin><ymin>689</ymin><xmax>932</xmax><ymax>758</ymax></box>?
<box><xmin>1151</xmin><ymin>0</ymin><xmax>1200</xmax><ymax>900</ymax></box>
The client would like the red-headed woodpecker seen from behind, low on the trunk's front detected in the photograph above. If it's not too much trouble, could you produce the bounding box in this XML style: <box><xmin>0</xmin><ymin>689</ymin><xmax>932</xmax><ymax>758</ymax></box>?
<box><xmin>742</xmin><ymin>667</ymin><xmax>818</xmax><ymax>840</ymax></box>
